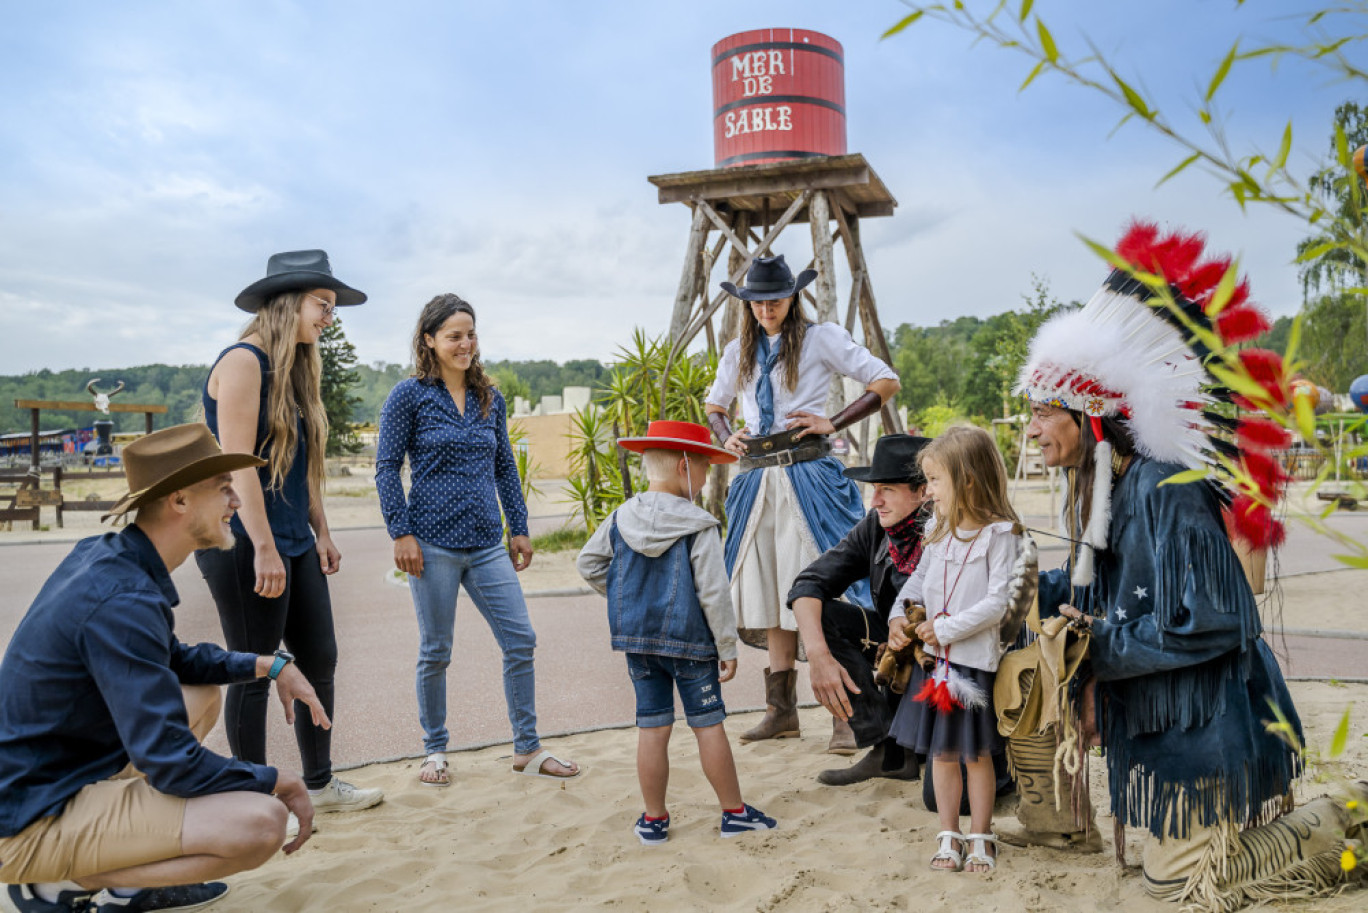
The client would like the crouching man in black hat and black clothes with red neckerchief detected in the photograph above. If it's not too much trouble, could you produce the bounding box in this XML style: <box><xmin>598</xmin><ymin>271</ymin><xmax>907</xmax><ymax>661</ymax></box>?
<box><xmin>788</xmin><ymin>434</ymin><xmax>930</xmax><ymax>786</ymax></box>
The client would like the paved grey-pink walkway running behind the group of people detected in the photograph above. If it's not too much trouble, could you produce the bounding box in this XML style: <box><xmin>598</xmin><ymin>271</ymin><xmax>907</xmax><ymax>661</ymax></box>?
<box><xmin>0</xmin><ymin>514</ymin><xmax>1368</xmax><ymax>765</ymax></box>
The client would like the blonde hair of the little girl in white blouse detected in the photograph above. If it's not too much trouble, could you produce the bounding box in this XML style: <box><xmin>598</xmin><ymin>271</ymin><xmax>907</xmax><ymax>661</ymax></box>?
<box><xmin>917</xmin><ymin>424</ymin><xmax>1021</xmax><ymax>542</ymax></box>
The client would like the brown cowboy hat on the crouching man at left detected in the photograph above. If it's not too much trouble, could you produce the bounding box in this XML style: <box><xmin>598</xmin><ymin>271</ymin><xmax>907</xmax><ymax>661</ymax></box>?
<box><xmin>100</xmin><ymin>423</ymin><xmax>265</xmax><ymax>520</ymax></box>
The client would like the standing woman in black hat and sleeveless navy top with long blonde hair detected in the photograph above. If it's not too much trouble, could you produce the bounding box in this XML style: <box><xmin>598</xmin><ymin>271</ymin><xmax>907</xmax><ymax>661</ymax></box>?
<box><xmin>196</xmin><ymin>250</ymin><xmax>383</xmax><ymax>812</ymax></box>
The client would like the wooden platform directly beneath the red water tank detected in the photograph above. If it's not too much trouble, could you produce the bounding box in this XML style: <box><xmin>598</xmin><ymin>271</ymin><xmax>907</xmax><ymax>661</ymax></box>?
<box><xmin>647</xmin><ymin>152</ymin><xmax>897</xmax><ymax>224</ymax></box>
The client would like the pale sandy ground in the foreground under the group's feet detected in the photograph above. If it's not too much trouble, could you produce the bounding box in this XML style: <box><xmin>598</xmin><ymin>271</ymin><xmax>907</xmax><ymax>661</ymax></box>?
<box><xmin>198</xmin><ymin>684</ymin><xmax>1368</xmax><ymax>913</ymax></box>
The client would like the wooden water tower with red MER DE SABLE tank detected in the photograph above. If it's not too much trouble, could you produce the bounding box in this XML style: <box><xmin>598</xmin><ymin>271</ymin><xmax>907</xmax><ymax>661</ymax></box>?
<box><xmin>648</xmin><ymin>29</ymin><xmax>903</xmax><ymax>440</ymax></box>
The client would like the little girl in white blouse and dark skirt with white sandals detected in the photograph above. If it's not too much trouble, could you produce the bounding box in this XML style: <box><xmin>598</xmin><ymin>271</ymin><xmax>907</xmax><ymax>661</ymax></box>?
<box><xmin>888</xmin><ymin>426</ymin><xmax>1019</xmax><ymax>872</ymax></box>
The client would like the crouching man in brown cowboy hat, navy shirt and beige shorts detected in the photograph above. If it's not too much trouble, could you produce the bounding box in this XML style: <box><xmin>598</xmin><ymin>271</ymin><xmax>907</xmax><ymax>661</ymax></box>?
<box><xmin>0</xmin><ymin>424</ymin><xmax>331</xmax><ymax>913</ymax></box>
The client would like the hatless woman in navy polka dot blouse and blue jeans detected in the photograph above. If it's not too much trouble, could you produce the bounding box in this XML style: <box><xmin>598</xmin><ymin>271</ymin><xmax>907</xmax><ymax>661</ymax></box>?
<box><xmin>375</xmin><ymin>294</ymin><xmax>580</xmax><ymax>786</ymax></box>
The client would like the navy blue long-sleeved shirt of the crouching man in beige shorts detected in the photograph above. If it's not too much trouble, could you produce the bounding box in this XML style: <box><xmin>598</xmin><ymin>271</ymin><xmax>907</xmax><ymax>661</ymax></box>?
<box><xmin>0</xmin><ymin>526</ymin><xmax>276</xmax><ymax>836</ymax></box>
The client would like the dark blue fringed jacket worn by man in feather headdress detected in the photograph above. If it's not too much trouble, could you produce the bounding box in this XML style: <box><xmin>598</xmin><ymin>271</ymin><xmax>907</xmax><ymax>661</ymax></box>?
<box><xmin>1040</xmin><ymin>456</ymin><xmax>1301</xmax><ymax>836</ymax></box>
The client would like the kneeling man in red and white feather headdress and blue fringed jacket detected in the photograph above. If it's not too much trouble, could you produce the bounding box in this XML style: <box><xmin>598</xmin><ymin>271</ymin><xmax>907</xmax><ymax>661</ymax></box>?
<box><xmin>1019</xmin><ymin>223</ymin><xmax>1368</xmax><ymax>910</ymax></box>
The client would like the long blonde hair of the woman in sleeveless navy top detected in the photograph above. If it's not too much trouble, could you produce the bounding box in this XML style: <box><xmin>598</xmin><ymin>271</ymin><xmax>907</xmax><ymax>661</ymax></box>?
<box><xmin>241</xmin><ymin>290</ymin><xmax>328</xmax><ymax>491</ymax></box>
